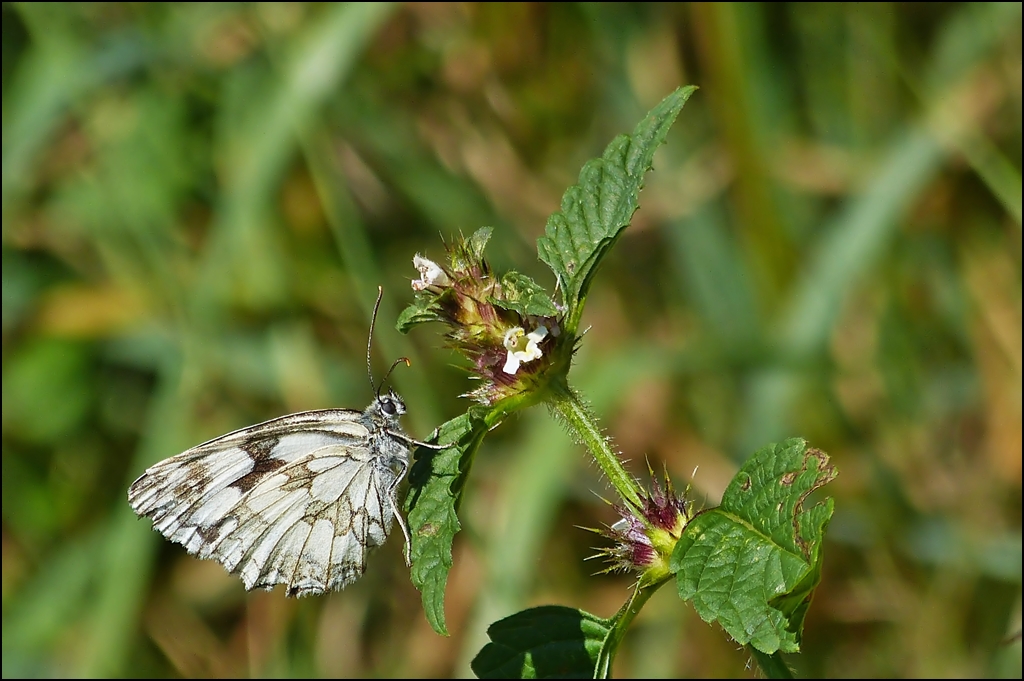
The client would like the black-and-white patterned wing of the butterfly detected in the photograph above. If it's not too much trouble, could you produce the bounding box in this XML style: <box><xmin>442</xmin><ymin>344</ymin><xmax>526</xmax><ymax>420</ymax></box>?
<box><xmin>128</xmin><ymin>410</ymin><xmax>403</xmax><ymax>596</ymax></box>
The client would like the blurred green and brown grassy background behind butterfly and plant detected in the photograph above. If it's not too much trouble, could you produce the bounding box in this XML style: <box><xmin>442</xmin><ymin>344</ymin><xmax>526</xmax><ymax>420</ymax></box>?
<box><xmin>2</xmin><ymin>3</ymin><xmax>1022</xmax><ymax>678</ymax></box>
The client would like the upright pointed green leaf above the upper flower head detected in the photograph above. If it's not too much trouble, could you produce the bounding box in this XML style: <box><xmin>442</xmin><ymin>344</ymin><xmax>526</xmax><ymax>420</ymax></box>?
<box><xmin>537</xmin><ymin>85</ymin><xmax>696</xmax><ymax>334</ymax></box>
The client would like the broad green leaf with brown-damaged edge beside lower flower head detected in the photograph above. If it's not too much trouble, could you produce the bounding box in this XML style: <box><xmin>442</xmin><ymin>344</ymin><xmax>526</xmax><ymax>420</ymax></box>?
<box><xmin>671</xmin><ymin>438</ymin><xmax>837</xmax><ymax>654</ymax></box>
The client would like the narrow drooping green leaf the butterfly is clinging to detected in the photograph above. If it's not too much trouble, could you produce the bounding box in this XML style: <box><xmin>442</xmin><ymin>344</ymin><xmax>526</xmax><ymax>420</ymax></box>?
<box><xmin>404</xmin><ymin>409</ymin><xmax>487</xmax><ymax>636</ymax></box>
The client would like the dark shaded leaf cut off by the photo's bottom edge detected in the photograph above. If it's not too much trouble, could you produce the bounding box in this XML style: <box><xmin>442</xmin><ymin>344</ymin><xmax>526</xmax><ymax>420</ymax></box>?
<box><xmin>471</xmin><ymin>605</ymin><xmax>610</xmax><ymax>679</ymax></box>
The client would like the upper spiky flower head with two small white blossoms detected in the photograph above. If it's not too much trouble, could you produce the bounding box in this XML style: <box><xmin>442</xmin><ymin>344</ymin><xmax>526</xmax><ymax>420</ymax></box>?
<box><xmin>398</xmin><ymin>228</ymin><xmax>571</xmax><ymax>405</ymax></box>
